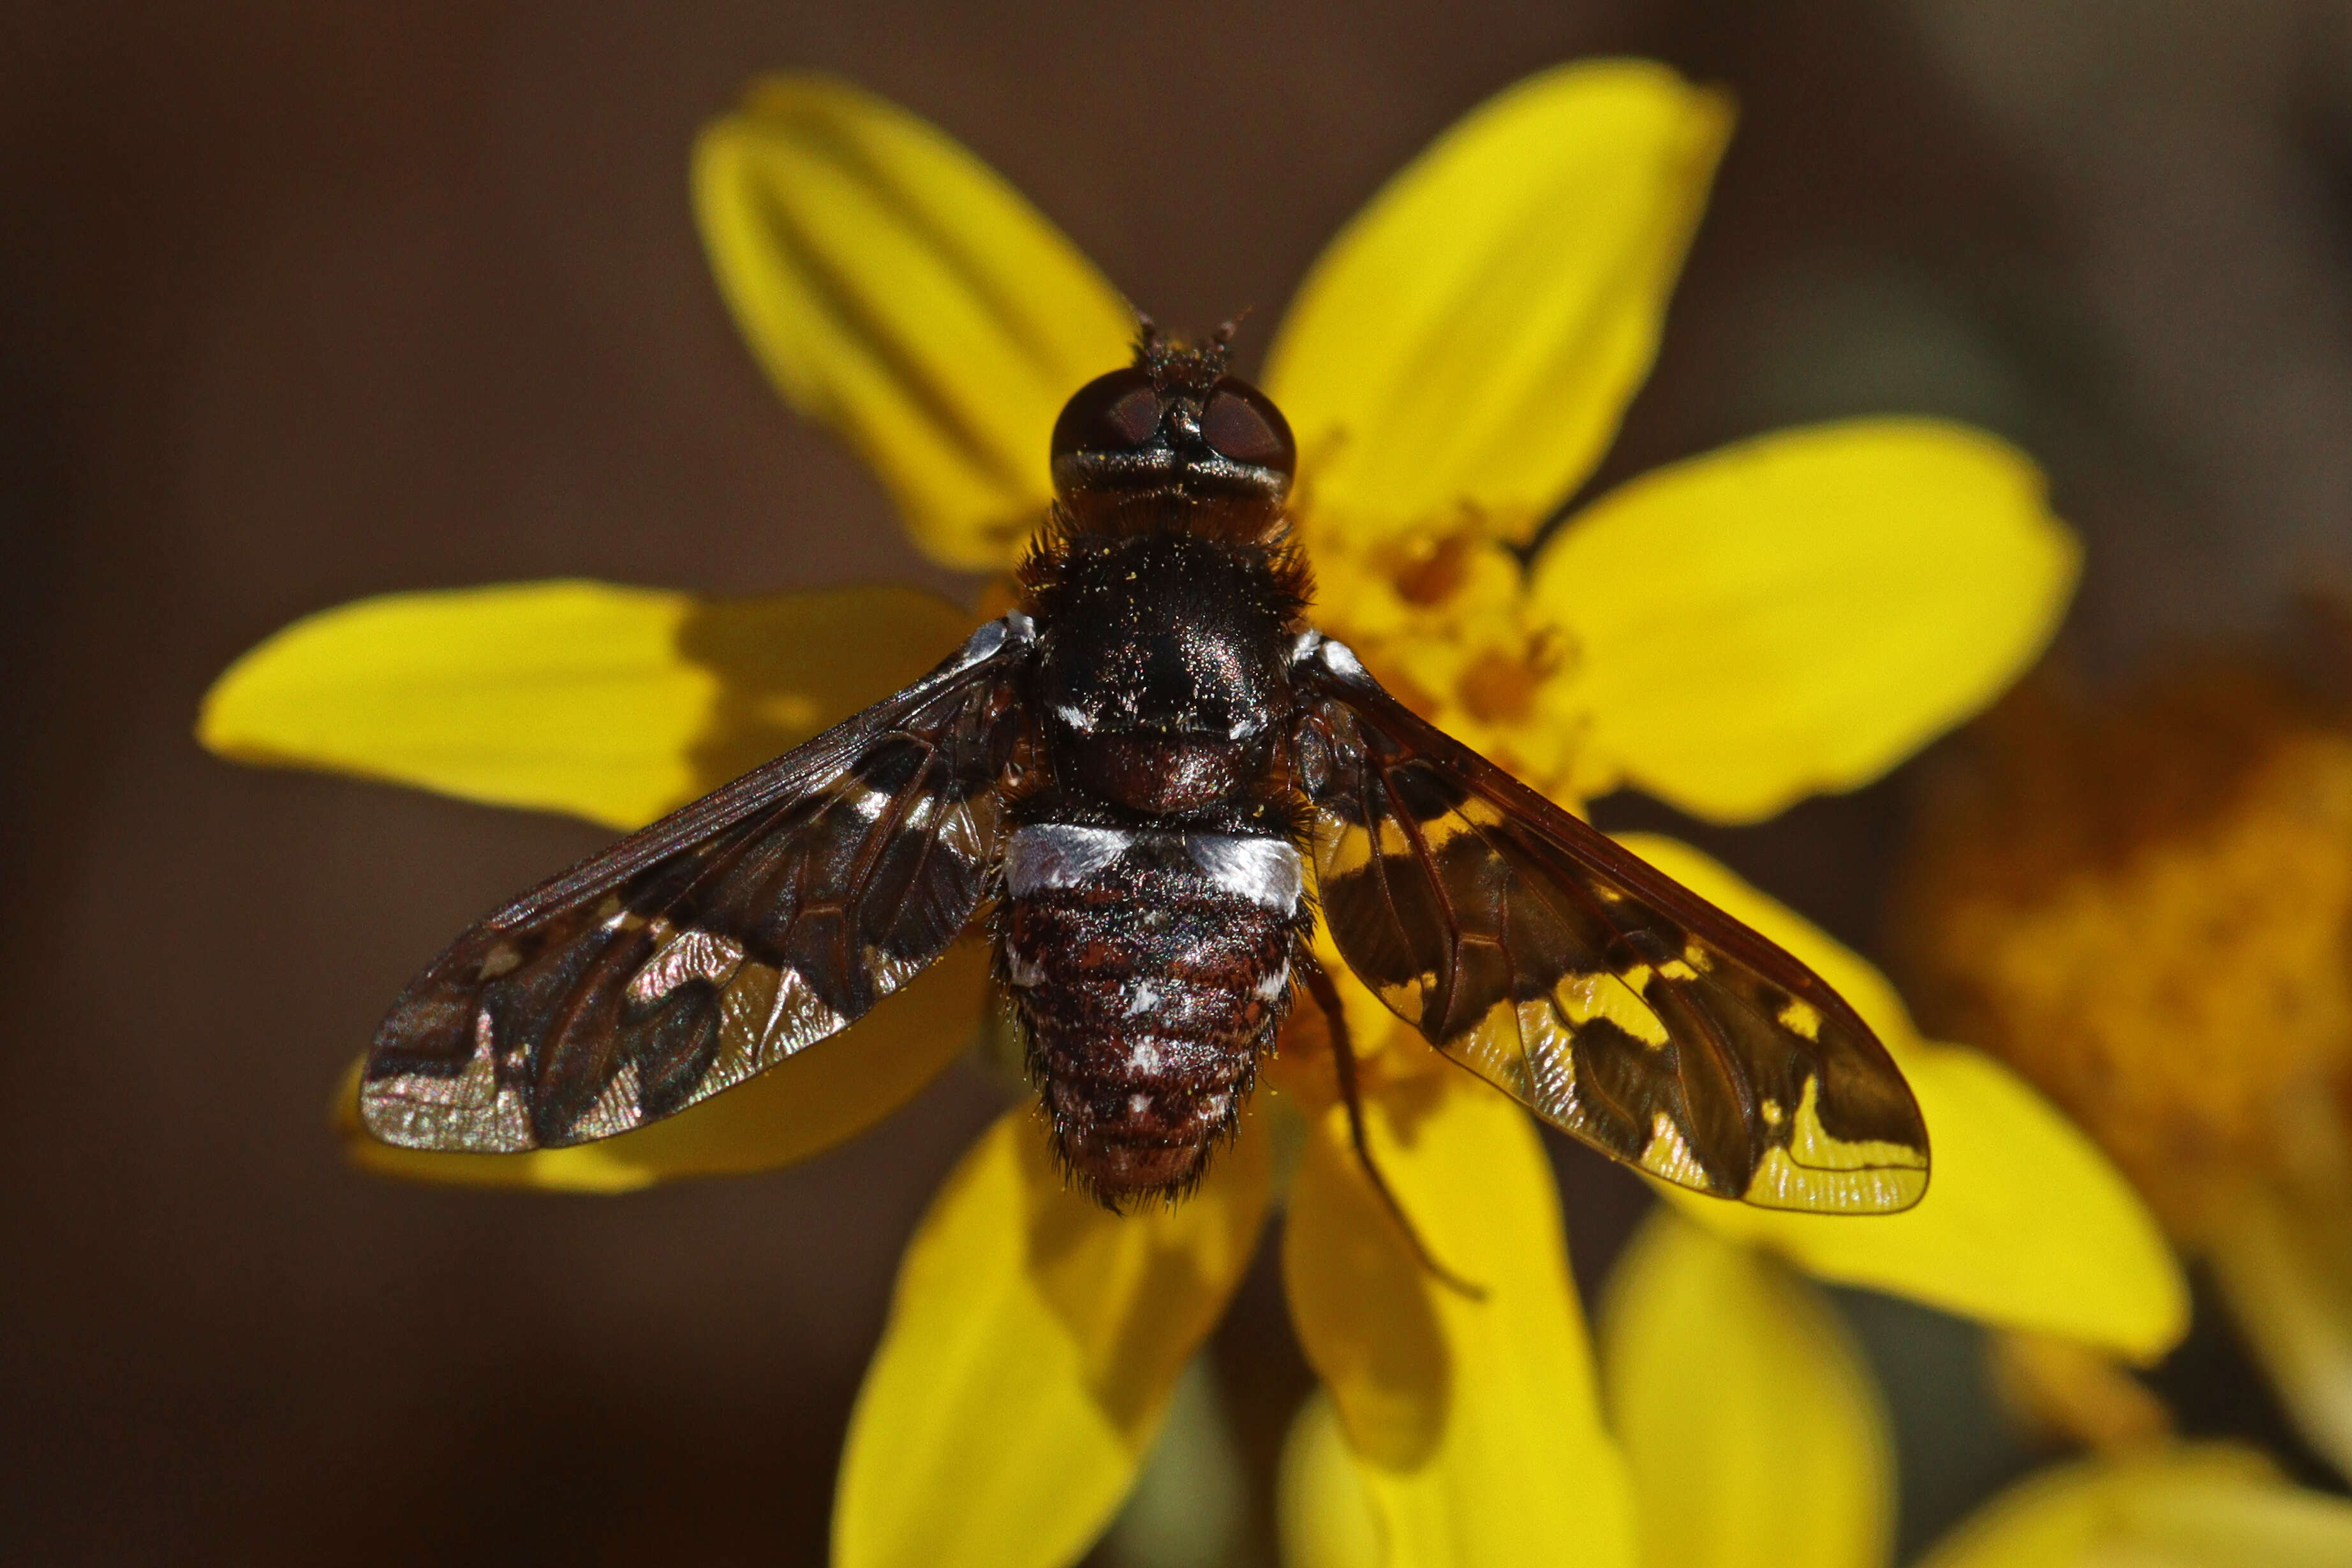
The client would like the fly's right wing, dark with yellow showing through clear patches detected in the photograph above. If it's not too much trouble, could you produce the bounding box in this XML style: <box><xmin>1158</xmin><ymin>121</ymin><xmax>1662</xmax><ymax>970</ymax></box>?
<box><xmin>1291</xmin><ymin>632</ymin><xmax>1928</xmax><ymax>1213</ymax></box>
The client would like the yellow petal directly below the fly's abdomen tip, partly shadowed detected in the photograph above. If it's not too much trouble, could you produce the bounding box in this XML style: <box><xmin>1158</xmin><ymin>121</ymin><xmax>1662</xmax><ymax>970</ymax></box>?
<box><xmin>832</xmin><ymin>1107</ymin><xmax>1273</xmax><ymax>1568</ymax></box>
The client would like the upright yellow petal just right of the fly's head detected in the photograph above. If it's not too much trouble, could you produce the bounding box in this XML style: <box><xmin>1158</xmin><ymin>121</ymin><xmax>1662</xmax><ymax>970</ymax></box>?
<box><xmin>1266</xmin><ymin>61</ymin><xmax>1731</xmax><ymax>538</ymax></box>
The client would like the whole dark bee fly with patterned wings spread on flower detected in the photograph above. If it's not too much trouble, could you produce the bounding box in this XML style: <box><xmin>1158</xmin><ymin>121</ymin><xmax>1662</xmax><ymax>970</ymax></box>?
<box><xmin>360</xmin><ymin>325</ymin><xmax>1927</xmax><ymax>1213</ymax></box>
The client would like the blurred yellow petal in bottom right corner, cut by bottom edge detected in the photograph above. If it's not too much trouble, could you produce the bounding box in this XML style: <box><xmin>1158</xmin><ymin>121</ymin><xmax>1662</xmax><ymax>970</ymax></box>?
<box><xmin>1919</xmin><ymin>1446</ymin><xmax>2352</xmax><ymax>1568</ymax></box>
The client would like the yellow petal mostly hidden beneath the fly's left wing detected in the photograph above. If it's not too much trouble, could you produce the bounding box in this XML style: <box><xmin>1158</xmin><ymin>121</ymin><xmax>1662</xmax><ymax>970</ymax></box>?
<box><xmin>334</xmin><ymin>940</ymin><xmax>988</xmax><ymax>1192</ymax></box>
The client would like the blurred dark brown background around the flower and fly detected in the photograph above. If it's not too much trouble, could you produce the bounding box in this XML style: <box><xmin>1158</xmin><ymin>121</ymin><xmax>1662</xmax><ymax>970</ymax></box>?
<box><xmin>0</xmin><ymin>0</ymin><xmax>2352</xmax><ymax>1564</ymax></box>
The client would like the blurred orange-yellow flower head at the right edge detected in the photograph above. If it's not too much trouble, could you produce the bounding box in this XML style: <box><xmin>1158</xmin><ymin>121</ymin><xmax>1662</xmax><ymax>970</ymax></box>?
<box><xmin>1905</xmin><ymin>663</ymin><xmax>2352</xmax><ymax>1474</ymax></box>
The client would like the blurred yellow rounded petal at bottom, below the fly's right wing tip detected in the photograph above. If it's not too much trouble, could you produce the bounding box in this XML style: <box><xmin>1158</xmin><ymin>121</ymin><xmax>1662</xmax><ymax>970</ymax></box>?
<box><xmin>1602</xmin><ymin>1208</ymin><xmax>1896</xmax><ymax>1568</ymax></box>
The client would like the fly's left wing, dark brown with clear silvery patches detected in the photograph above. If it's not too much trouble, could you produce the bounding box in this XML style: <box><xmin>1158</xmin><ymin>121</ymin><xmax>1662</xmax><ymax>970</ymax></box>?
<box><xmin>360</xmin><ymin>616</ymin><xmax>1035</xmax><ymax>1152</ymax></box>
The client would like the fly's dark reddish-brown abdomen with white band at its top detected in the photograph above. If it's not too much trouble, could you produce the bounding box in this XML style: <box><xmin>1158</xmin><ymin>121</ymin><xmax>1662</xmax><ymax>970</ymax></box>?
<box><xmin>1004</xmin><ymin>823</ymin><xmax>1305</xmax><ymax>1204</ymax></box>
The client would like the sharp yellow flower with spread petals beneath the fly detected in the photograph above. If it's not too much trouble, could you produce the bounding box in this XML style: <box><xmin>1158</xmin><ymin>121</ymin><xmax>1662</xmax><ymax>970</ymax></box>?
<box><xmin>202</xmin><ymin>61</ymin><xmax>2183</xmax><ymax>1568</ymax></box>
